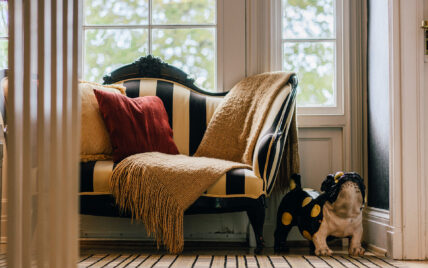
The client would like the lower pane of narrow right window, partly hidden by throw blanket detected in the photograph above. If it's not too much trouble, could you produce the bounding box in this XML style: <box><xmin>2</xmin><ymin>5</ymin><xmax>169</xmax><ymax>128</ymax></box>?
<box><xmin>283</xmin><ymin>42</ymin><xmax>335</xmax><ymax>106</ymax></box>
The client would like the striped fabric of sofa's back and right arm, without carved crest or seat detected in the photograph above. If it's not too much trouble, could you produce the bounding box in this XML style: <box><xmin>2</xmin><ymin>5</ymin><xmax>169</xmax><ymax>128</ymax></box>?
<box><xmin>112</xmin><ymin>74</ymin><xmax>296</xmax><ymax>194</ymax></box>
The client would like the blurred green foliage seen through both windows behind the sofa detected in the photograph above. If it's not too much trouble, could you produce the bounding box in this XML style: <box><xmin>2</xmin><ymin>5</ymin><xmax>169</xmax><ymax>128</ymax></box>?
<box><xmin>83</xmin><ymin>0</ymin><xmax>336</xmax><ymax>103</ymax></box>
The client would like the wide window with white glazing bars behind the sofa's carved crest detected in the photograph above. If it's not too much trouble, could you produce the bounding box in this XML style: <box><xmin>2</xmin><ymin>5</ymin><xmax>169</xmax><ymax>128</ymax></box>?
<box><xmin>83</xmin><ymin>0</ymin><xmax>217</xmax><ymax>90</ymax></box>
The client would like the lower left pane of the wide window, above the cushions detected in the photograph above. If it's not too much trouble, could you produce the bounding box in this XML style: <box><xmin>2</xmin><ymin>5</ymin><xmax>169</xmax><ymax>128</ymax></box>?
<box><xmin>84</xmin><ymin>29</ymin><xmax>148</xmax><ymax>82</ymax></box>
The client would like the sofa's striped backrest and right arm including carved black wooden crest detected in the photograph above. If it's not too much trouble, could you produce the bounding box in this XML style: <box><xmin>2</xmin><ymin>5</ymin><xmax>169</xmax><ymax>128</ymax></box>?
<box><xmin>103</xmin><ymin>55</ymin><xmax>297</xmax><ymax>195</ymax></box>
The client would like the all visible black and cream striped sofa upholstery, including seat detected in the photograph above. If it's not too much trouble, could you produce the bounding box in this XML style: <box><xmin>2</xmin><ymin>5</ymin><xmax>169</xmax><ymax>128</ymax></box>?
<box><xmin>80</xmin><ymin>78</ymin><xmax>295</xmax><ymax>199</ymax></box>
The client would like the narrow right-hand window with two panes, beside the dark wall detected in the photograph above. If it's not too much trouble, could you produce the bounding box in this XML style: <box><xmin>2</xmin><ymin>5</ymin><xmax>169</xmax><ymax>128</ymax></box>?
<box><xmin>282</xmin><ymin>0</ymin><xmax>343</xmax><ymax>113</ymax></box>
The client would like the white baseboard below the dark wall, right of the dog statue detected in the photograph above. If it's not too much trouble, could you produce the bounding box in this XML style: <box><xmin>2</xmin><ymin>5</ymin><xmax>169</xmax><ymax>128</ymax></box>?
<box><xmin>363</xmin><ymin>207</ymin><xmax>390</xmax><ymax>255</ymax></box>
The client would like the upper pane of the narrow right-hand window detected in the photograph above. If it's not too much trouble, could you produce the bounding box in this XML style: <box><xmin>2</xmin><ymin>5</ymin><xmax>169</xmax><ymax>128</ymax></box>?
<box><xmin>283</xmin><ymin>0</ymin><xmax>335</xmax><ymax>39</ymax></box>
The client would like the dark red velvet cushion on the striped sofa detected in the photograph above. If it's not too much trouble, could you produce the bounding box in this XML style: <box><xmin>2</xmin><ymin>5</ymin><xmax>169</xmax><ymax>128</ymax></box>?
<box><xmin>94</xmin><ymin>89</ymin><xmax>178</xmax><ymax>162</ymax></box>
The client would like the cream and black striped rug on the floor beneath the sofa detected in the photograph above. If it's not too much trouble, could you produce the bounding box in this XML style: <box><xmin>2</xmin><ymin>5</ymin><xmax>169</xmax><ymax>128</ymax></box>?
<box><xmin>78</xmin><ymin>254</ymin><xmax>406</xmax><ymax>268</ymax></box>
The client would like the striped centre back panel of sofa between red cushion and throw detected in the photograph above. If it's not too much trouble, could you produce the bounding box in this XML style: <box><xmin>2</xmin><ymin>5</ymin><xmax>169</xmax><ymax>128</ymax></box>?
<box><xmin>115</xmin><ymin>78</ymin><xmax>222</xmax><ymax>155</ymax></box>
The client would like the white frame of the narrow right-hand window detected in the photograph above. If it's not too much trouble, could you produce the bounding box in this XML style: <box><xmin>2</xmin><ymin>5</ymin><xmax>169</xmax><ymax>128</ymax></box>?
<box><xmin>277</xmin><ymin>0</ymin><xmax>349</xmax><ymax>116</ymax></box>
